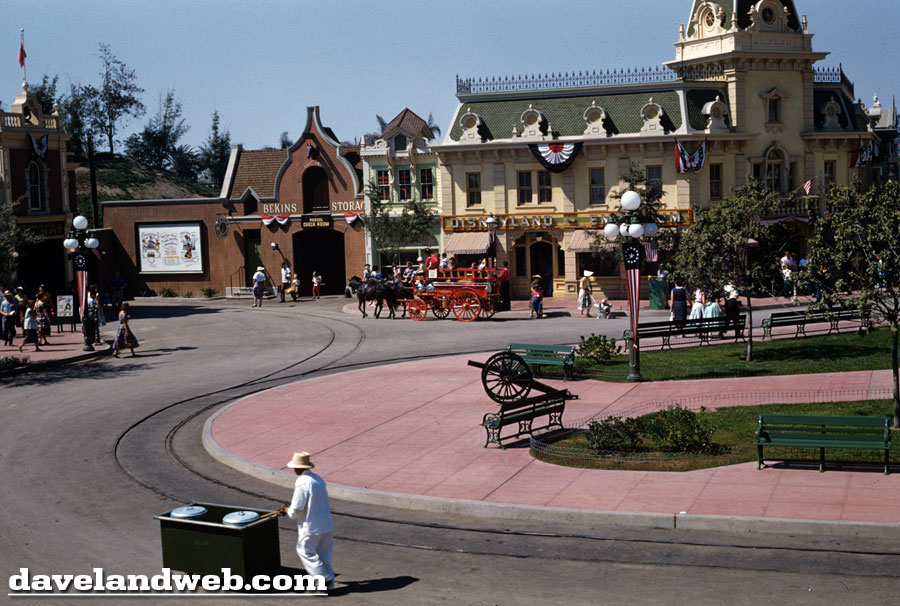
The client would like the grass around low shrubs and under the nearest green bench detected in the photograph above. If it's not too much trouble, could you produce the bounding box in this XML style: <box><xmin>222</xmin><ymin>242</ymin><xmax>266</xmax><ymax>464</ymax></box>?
<box><xmin>531</xmin><ymin>400</ymin><xmax>900</xmax><ymax>471</ymax></box>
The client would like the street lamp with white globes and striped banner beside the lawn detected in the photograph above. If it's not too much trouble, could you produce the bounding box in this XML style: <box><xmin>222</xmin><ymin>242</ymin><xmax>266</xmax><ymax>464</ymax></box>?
<box><xmin>603</xmin><ymin>190</ymin><xmax>659</xmax><ymax>383</ymax></box>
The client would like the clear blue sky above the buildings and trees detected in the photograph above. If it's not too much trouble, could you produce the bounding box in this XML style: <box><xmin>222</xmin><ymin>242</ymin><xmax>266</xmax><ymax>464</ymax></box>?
<box><xmin>0</xmin><ymin>0</ymin><xmax>900</xmax><ymax>149</ymax></box>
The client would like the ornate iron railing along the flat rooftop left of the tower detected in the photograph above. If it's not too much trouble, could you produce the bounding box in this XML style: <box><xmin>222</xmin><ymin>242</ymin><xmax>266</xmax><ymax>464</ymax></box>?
<box><xmin>456</xmin><ymin>66</ymin><xmax>724</xmax><ymax>95</ymax></box>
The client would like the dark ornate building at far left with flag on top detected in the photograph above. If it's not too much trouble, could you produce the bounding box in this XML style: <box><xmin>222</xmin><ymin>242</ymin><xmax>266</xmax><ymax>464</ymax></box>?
<box><xmin>0</xmin><ymin>83</ymin><xmax>77</xmax><ymax>293</ymax></box>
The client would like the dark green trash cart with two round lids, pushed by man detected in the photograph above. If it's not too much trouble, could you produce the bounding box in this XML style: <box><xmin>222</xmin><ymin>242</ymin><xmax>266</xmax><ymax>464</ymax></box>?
<box><xmin>153</xmin><ymin>503</ymin><xmax>281</xmax><ymax>579</ymax></box>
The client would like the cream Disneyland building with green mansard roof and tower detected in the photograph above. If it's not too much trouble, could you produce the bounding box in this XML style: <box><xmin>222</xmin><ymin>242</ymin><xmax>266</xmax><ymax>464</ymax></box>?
<box><xmin>432</xmin><ymin>0</ymin><xmax>875</xmax><ymax>297</ymax></box>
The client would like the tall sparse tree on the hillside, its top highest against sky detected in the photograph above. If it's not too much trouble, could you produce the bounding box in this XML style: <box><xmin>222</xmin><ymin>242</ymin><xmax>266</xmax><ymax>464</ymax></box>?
<box><xmin>91</xmin><ymin>42</ymin><xmax>147</xmax><ymax>153</ymax></box>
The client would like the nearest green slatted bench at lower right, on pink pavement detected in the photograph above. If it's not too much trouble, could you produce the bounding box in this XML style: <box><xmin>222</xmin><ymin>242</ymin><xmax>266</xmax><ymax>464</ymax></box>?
<box><xmin>753</xmin><ymin>414</ymin><xmax>891</xmax><ymax>474</ymax></box>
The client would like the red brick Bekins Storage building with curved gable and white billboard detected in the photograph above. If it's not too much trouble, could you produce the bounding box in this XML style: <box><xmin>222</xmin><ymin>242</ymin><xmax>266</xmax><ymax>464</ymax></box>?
<box><xmin>103</xmin><ymin>107</ymin><xmax>365</xmax><ymax>296</ymax></box>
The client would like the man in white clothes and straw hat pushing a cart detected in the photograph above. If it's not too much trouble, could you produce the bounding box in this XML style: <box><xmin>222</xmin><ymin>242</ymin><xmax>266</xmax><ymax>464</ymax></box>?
<box><xmin>279</xmin><ymin>451</ymin><xmax>334</xmax><ymax>590</ymax></box>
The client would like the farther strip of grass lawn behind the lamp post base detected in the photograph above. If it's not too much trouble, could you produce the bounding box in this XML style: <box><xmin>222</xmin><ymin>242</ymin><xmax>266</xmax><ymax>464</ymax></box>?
<box><xmin>575</xmin><ymin>328</ymin><xmax>891</xmax><ymax>382</ymax></box>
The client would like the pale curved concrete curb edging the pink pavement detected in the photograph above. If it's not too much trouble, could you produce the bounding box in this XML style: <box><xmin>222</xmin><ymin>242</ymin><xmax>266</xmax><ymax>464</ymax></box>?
<box><xmin>202</xmin><ymin>392</ymin><xmax>900</xmax><ymax>540</ymax></box>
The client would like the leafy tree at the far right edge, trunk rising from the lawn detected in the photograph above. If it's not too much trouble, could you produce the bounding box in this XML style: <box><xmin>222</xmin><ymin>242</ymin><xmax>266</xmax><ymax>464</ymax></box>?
<box><xmin>801</xmin><ymin>181</ymin><xmax>900</xmax><ymax>429</ymax></box>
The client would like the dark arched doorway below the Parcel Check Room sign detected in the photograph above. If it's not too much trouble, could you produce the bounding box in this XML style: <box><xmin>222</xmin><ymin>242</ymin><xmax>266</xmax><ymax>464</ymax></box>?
<box><xmin>294</xmin><ymin>229</ymin><xmax>347</xmax><ymax>296</ymax></box>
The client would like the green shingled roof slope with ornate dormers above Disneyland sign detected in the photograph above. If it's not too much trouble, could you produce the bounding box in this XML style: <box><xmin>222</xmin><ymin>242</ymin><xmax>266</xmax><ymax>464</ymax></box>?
<box><xmin>450</xmin><ymin>90</ymin><xmax>684</xmax><ymax>141</ymax></box>
